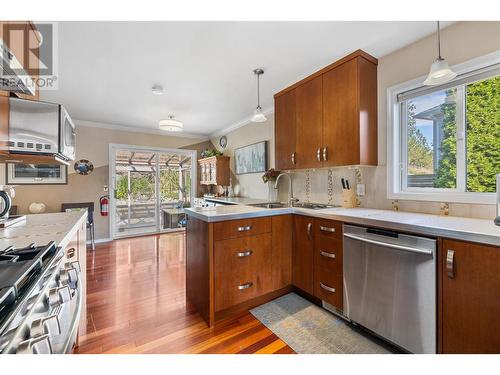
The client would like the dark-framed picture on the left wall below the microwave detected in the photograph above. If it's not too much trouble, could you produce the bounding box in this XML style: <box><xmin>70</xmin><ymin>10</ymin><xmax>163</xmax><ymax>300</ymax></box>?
<box><xmin>5</xmin><ymin>163</ymin><xmax>68</xmax><ymax>185</ymax></box>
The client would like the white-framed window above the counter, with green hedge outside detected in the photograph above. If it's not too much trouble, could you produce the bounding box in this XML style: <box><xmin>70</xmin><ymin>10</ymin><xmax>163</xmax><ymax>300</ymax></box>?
<box><xmin>388</xmin><ymin>54</ymin><xmax>500</xmax><ymax>203</ymax></box>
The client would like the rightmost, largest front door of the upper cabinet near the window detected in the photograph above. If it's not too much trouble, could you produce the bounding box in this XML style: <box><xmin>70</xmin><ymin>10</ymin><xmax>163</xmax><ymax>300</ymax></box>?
<box><xmin>323</xmin><ymin>59</ymin><xmax>359</xmax><ymax>166</ymax></box>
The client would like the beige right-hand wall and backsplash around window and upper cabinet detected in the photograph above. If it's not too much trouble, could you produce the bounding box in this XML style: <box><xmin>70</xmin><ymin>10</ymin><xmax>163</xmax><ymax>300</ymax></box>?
<box><xmin>212</xmin><ymin>22</ymin><xmax>500</xmax><ymax>218</ymax></box>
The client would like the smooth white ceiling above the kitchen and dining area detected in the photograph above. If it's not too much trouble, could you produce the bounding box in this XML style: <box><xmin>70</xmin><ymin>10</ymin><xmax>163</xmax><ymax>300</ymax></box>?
<box><xmin>41</xmin><ymin>21</ymin><xmax>454</xmax><ymax>136</ymax></box>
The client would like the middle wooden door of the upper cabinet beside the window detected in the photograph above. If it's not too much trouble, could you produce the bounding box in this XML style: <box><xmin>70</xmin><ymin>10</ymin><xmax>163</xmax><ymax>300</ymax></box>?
<box><xmin>295</xmin><ymin>76</ymin><xmax>323</xmax><ymax>169</ymax></box>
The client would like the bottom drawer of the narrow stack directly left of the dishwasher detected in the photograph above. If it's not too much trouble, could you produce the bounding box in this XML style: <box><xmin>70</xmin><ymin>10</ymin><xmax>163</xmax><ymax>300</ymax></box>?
<box><xmin>314</xmin><ymin>267</ymin><xmax>342</xmax><ymax>310</ymax></box>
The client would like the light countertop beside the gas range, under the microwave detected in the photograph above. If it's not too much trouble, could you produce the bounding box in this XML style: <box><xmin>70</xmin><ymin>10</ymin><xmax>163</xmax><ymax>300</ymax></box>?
<box><xmin>0</xmin><ymin>211</ymin><xmax>87</xmax><ymax>250</ymax></box>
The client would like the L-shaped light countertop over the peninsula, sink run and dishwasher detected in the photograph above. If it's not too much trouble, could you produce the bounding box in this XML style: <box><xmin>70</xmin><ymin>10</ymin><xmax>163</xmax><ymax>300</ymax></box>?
<box><xmin>186</xmin><ymin>205</ymin><xmax>500</xmax><ymax>246</ymax></box>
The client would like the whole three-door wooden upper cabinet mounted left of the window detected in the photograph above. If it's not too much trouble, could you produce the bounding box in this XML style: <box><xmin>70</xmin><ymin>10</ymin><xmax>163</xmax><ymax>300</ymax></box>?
<box><xmin>274</xmin><ymin>50</ymin><xmax>377</xmax><ymax>169</ymax></box>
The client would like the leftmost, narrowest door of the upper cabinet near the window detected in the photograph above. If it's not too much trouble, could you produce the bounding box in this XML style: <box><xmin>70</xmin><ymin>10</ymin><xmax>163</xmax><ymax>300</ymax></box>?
<box><xmin>274</xmin><ymin>90</ymin><xmax>295</xmax><ymax>170</ymax></box>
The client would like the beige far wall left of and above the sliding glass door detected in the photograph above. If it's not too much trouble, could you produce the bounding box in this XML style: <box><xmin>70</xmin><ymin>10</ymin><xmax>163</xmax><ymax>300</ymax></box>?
<box><xmin>2</xmin><ymin>121</ymin><xmax>213</xmax><ymax>239</ymax></box>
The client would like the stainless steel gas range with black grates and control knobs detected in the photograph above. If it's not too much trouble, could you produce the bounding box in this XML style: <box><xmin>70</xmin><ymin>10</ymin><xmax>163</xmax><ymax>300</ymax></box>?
<box><xmin>0</xmin><ymin>242</ymin><xmax>82</xmax><ymax>354</ymax></box>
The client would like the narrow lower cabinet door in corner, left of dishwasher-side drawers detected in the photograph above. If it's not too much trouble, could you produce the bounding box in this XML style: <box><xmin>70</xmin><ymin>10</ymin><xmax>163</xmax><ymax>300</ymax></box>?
<box><xmin>292</xmin><ymin>215</ymin><xmax>314</xmax><ymax>295</ymax></box>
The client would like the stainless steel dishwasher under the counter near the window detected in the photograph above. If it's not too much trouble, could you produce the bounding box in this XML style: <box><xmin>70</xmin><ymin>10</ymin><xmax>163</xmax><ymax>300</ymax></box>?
<box><xmin>343</xmin><ymin>225</ymin><xmax>436</xmax><ymax>353</ymax></box>
